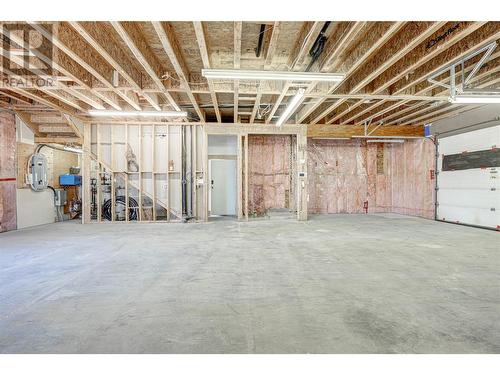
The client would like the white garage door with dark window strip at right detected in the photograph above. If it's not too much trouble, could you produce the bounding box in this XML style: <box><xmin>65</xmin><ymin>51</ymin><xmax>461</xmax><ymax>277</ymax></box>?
<box><xmin>437</xmin><ymin>126</ymin><xmax>500</xmax><ymax>229</ymax></box>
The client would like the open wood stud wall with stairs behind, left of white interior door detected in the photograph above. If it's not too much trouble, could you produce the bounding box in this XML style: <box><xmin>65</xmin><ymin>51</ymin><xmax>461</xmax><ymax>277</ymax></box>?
<box><xmin>83</xmin><ymin>123</ymin><xmax>206</xmax><ymax>222</ymax></box>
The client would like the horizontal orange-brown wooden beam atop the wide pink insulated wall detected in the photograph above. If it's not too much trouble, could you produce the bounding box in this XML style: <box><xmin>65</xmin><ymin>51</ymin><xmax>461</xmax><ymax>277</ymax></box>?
<box><xmin>307</xmin><ymin>124</ymin><xmax>424</xmax><ymax>138</ymax></box>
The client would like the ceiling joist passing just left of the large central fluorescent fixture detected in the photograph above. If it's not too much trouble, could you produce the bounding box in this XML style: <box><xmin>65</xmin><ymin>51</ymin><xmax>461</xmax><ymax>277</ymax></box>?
<box><xmin>152</xmin><ymin>21</ymin><xmax>205</xmax><ymax>122</ymax></box>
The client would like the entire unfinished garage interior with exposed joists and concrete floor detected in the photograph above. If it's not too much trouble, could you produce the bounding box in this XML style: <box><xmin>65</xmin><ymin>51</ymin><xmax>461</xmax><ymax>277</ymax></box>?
<box><xmin>0</xmin><ymin>3</ymin><xmax>500</xmax><ymax>368</ymax></box>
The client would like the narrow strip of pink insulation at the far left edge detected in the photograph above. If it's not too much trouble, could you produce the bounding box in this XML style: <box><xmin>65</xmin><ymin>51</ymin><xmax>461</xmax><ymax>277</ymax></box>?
<box><xmin>0</xmin><ymin>111</ymin><xmax>17</xmax><ymax>232</ymax></box>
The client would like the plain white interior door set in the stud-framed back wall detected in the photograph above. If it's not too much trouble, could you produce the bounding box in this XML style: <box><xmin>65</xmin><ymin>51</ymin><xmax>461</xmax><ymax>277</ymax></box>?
<box><xmin>210</xmin><ymin>159</ymin><xmax>236</xmax><ymax>215</ymax></box>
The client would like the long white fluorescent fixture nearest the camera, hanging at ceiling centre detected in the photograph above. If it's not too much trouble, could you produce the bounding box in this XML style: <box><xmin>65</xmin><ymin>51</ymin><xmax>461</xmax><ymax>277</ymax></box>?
<box><xmin>201</xmin><ymin>69</ymin><xmax>344</xmax><ymax>82</ymax></box>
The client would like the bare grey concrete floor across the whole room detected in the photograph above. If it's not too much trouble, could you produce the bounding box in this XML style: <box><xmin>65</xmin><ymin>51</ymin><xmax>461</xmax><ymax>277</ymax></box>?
<box><xmin>0</xmin><ymin>215</ymin><xmax>500</xmax><ymax>353</ymax></box>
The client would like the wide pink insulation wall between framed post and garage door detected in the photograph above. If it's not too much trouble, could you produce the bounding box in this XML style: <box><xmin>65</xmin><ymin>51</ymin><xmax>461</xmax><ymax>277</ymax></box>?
<box><xmin>308</xmin><ymin>139</ymin><xmax>434</xmax><ymax>218</ymax></box>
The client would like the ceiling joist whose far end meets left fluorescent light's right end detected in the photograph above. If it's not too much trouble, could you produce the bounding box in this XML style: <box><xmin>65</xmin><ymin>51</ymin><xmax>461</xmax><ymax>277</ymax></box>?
<box><xmin>111</xmin><ymin>21</ymin><xmax>181</xmax><ymax>111</ymax></box>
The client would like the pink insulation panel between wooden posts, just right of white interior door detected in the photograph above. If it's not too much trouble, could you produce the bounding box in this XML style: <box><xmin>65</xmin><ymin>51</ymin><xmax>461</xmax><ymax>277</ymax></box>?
<box><xmin>248</xmin><ymin>135</ymin><xmax>295</xmax><ymax>215</ymax></box>
